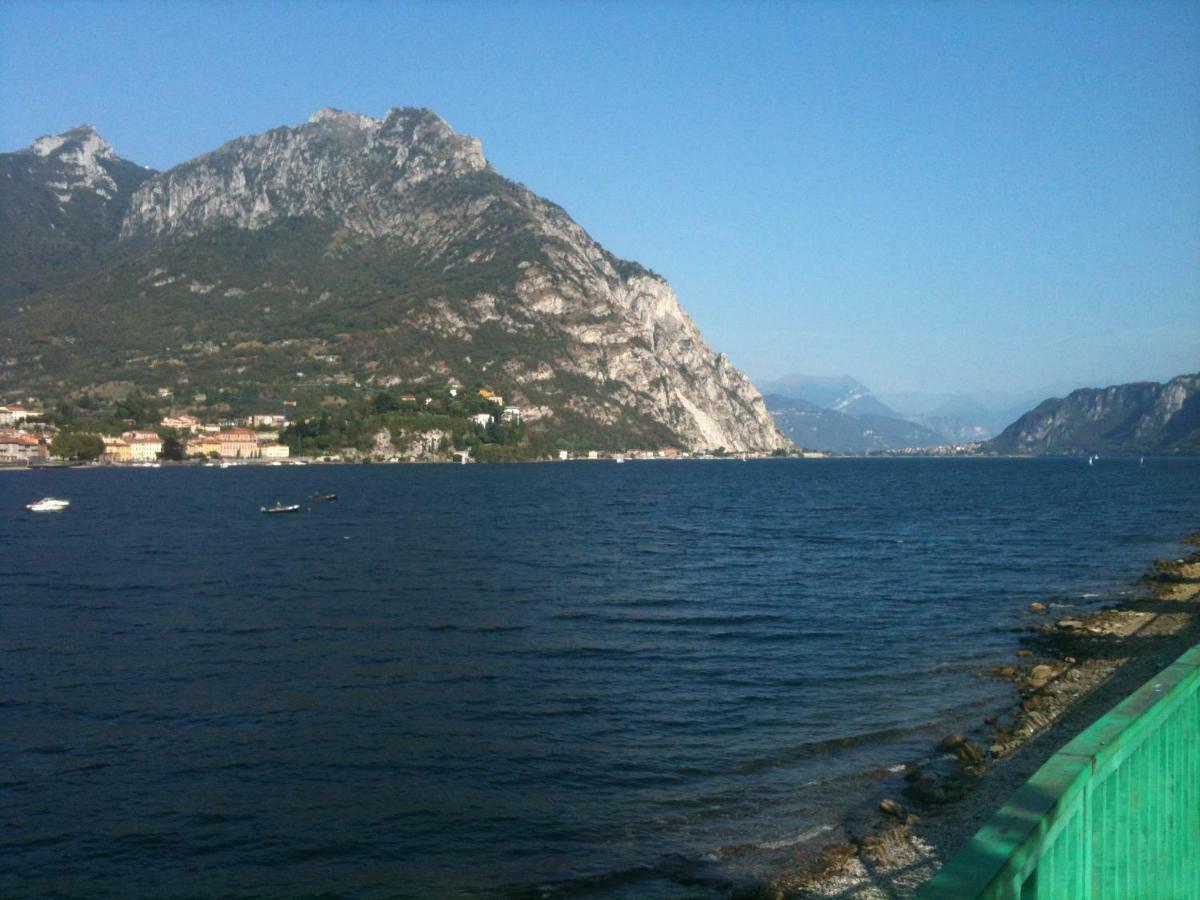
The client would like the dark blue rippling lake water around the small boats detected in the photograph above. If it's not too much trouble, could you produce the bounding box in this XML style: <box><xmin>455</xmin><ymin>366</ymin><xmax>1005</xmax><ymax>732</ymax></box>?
<box><xmin>0</xmin><ymin>460</ymin><xmax>1200</xmax><ymax>898</ymax></box>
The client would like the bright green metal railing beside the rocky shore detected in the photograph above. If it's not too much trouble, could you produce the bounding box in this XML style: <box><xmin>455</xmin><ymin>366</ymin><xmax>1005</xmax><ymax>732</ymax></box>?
<box><xmin>918</xmin><ymin>646</ymin><xmax>1200</xmax><ymax>900</ymax></box>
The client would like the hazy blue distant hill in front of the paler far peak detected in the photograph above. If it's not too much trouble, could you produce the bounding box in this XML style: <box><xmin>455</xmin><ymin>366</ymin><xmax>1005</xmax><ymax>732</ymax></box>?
<box><xmin>764</xmin><ymin>394</ymin><xmax>946</xmax><ymax>454</ymax></box>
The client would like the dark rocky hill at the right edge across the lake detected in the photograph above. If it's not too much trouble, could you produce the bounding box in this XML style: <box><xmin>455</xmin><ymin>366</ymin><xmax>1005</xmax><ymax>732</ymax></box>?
<box><xmin>984</xmin><ymin>374</ymin><xmax>1200</xmax><ymax>455</ymax></box>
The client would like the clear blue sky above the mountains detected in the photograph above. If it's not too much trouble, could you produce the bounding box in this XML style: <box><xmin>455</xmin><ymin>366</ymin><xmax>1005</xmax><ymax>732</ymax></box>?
<box><xmin>0</xmin><ymin>0</ymin><xmax>1200</xmax><ymax>392</ymax></box>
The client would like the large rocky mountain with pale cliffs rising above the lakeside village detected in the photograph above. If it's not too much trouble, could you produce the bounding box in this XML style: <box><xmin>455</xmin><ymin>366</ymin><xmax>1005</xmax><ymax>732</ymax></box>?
<box><xmin>0</xmin><ymin>109</ymin><xmax>787</xmax><ymax>451</ymax></box>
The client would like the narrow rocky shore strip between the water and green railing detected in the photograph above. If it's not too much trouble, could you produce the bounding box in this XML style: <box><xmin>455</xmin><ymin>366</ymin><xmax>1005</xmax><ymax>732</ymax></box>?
<box><xmin>755</xmin><ymin>533</ymin><xmax>1200</xmax><ymax>900</ymax></box>
